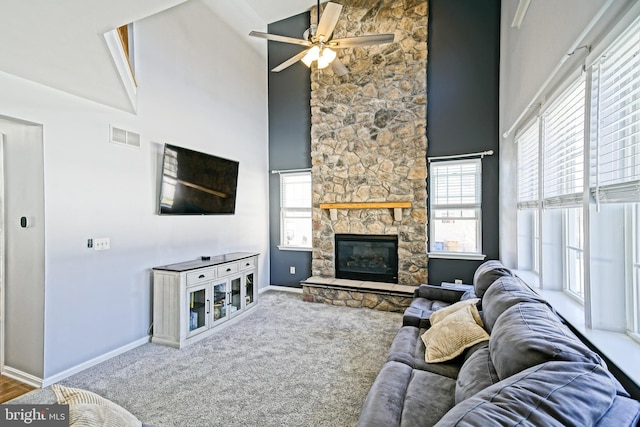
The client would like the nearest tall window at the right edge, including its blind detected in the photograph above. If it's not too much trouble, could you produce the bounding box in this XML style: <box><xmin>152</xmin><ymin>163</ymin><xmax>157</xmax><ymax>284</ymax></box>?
<box><xmin>590</xmin><ymin>15</ymin><xmax>640</xmax><ymax>339</ymax></box>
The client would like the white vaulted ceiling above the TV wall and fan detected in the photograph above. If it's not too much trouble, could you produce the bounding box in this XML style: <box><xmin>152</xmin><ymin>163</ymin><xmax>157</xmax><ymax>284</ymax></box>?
<box><xmin>0</xmin><ymin>0</ymin><xmax>316</xmax><ymax>111</ymax></box>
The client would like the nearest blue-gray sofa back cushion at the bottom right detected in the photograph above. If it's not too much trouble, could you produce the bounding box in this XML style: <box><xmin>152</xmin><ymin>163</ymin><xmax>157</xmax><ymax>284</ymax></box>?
<box><xmin>436</xmin><ymin>362</ymin><xmax>622</xmax><ymax>426</ymax></box>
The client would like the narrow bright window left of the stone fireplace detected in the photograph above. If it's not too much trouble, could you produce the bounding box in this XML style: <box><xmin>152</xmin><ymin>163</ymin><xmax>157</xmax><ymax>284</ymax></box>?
<box><xmin>279</xmin><ymin>172</ymin><xmax>311</xmax><ymax>249</ymax></box>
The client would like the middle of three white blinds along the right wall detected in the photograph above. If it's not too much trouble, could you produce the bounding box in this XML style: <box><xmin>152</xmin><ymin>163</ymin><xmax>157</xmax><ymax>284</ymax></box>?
<box><xmin>542</xmin><ymin>76</ymin><xmax>585</xmax><ymax>208</ymax></box>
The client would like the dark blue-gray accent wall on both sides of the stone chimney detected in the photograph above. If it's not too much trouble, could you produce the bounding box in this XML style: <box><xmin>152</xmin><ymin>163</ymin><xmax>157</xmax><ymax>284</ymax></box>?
<box><xmin>268</xmin><ymin>0</ymin><xmax>500</xmax><ymax>286</ymax></box>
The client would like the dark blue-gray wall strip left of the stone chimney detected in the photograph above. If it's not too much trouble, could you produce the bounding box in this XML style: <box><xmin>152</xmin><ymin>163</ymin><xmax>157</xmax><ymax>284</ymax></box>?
<box><xmin>268</xmin><ymin>12</ymin><xmax>311</xmax><ymax>287</ymax></box>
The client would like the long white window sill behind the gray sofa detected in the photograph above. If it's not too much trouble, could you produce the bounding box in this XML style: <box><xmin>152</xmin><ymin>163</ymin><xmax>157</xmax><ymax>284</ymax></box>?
<box><xmin>515</xmin><ymin>270</ymin><xmax>640</xmax><ymax>385</ymax></box>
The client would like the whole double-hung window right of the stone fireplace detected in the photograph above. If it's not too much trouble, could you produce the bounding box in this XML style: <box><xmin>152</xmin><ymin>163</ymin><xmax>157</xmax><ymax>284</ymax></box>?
<box><xmin>429</xmin><ymin>159</ymin><xmax>482</xmax><ymax>256</ymax></box>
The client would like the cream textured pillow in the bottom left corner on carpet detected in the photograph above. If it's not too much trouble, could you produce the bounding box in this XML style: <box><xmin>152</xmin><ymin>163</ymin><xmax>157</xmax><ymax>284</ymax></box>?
<box><xmin>51</xmin><ymin>384</ymin><xmax>142</xmax><ymax>427</ymax></box>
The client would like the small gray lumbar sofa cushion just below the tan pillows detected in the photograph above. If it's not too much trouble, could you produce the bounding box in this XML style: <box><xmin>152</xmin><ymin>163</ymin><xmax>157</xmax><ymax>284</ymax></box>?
<box><xmin>455</xmin><ymin>342</ymin><xmax>500</xmax><ymax>405</ymax></box>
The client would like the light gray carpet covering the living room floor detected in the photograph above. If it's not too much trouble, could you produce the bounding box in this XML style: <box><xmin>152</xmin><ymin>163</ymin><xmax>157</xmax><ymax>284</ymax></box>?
<box><xmin>11</xmin><ymin>291</ymin><xmax>402</xmax><ymax>427</ymax></box>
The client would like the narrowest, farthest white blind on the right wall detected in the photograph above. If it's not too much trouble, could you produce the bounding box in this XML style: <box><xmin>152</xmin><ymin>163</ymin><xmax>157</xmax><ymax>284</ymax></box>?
<box><xmin>515</xmin><ymin>120</ymin><xmax>540</xmax><ymax>209</ymax></box>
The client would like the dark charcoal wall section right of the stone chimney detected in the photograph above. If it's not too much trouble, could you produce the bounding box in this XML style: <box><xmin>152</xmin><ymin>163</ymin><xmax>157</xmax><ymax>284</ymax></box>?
<box><xmin>427</xmin><ymin>0</ymin><xmax>500</xmax><ymax>283</ymax></box>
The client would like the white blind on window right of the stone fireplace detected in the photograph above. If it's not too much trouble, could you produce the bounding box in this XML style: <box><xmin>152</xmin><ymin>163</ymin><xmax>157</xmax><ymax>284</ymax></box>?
<box><xmin>430</xmin><ymin>159</ymin><xmax>482</xmax><ymax>209</ymax></box>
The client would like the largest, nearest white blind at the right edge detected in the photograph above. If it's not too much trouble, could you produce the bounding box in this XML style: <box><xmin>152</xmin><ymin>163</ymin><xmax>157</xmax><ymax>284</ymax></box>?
<box><xmin>590</xmin><ymin>17</ymin><xmax>640</xmax><ymax>203</ymax></box>
